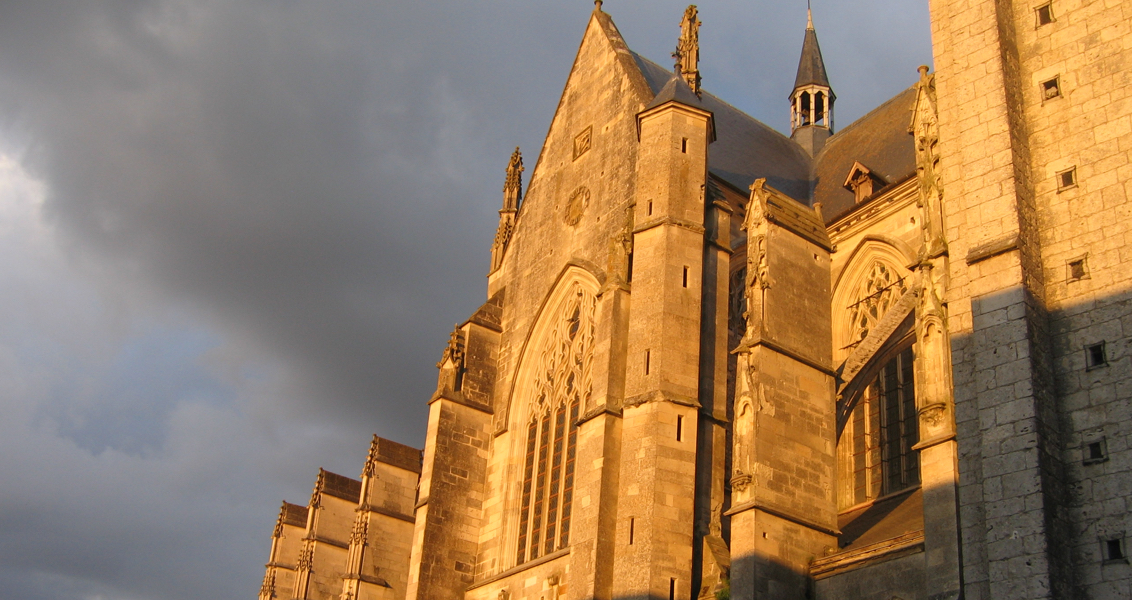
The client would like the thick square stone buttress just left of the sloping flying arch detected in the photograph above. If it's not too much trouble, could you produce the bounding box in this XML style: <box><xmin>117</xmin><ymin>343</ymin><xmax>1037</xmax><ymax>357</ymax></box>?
<box><xmin>727</xmin><ymin>180</ymin><xmax>838</xmax><ymax>600</ymax></box>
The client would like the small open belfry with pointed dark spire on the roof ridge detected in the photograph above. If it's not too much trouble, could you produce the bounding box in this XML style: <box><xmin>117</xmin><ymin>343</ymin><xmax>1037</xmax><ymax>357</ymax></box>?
<box><xmin>790</xmin><ymin>9</ymin><xmax>837</xmax><ymax>156</ymax></box>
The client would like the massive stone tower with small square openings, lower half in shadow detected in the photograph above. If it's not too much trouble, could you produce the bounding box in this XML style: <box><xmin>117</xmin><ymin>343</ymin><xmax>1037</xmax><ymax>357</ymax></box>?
<box><xmin>931</xmin><ymin>0</ymin><xmax>1132</xmax><ymax>599</ymax></box>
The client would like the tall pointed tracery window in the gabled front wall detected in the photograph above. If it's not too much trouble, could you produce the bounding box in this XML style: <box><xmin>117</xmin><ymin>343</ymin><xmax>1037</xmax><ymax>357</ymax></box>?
<box><xmin>515</xmin><ymin>283</ymin><xmax>597</xmax><ymax>564</ymax></box>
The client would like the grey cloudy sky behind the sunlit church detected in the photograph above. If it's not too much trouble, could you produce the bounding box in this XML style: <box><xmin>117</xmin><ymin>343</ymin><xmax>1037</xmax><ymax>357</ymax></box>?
<box><xmin>0</xmin><ymin>0</ymin><xmax>931</xmax><ymax>599</ymax></box>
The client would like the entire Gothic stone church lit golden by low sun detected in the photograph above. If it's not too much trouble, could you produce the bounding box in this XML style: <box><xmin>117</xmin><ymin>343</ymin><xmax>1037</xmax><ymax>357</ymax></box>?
<box><xmin>260</xmin><ymin>0</ymin><xmax>1132</xmax><ymax>600</ymax></box>
